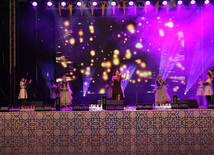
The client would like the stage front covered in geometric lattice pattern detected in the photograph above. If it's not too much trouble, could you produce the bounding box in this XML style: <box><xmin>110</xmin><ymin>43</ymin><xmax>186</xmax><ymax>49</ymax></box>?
<box><xmin>0</xmin><ymin>109</ymin><xmax>214</xmax><ymax>155</ymax></box>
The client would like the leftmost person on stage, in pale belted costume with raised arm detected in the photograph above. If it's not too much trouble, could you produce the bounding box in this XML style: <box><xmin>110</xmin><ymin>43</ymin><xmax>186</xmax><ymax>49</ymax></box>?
<box><xmin>18</xmin><ymin>77</ymin><xmax>32</xmax><ymax>106</ymax></box>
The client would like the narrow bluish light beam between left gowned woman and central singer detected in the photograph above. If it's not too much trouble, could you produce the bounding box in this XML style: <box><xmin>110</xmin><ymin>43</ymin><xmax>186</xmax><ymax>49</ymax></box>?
<box><xmin>82</xmin><ymin>67</ymin><xmax>95</xmax><ymax>96</ymax></box>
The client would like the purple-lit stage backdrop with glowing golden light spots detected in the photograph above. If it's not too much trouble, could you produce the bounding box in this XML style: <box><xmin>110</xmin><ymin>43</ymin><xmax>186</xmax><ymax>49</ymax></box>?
<box><xmin>56</xmin><ymin>6</ymin><xmax>213</xmax><ymax>104</ymax></box>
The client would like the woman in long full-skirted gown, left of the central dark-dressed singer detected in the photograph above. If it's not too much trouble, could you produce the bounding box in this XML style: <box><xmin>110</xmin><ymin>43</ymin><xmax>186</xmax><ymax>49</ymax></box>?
<box><xmin>59</xmin><ymin>75</ymin><xmax>73</xmax><ymax>107</ymax></box>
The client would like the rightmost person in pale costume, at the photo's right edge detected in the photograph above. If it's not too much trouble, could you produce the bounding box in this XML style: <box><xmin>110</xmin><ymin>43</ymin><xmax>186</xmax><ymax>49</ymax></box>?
<box><xmin>201</xmin><ymin>73</ymin><xmax>213</xmax><ymax>106</ymax></box>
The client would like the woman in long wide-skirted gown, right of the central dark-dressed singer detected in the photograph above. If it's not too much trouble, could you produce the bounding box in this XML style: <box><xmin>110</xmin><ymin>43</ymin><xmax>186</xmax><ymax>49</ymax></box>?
<box><xmin>155</xmin><ymin>75</ymin><xmax>171</xmax><ymax>105</ymax></box>
